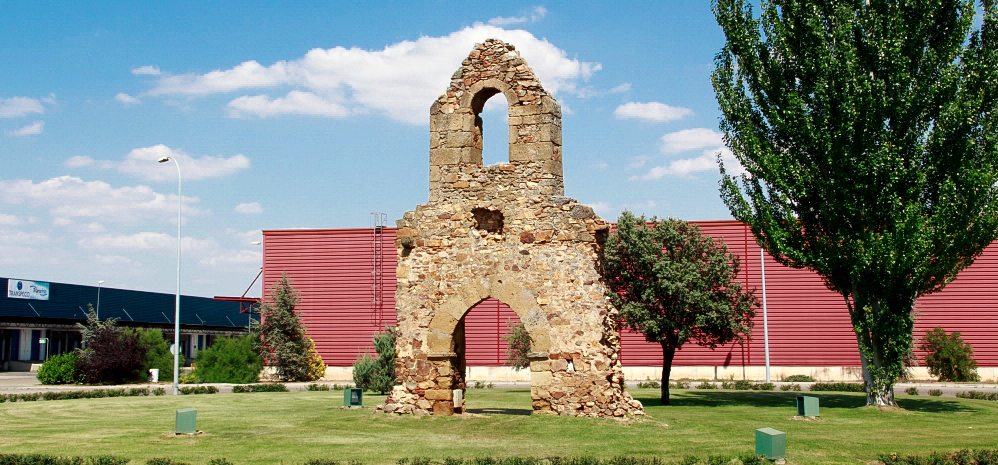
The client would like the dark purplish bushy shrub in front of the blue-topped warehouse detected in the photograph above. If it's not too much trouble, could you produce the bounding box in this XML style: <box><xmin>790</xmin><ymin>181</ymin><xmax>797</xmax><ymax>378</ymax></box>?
<box><xmin>75</xmin><ymin>305</ymin><xmax>145</xmax><ymax>384</ymax></box>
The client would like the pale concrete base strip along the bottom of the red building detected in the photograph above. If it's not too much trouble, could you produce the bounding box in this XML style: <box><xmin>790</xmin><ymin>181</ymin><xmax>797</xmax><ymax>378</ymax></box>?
<box><xmin>322</xmin><ymin>366</ymin><xmax>998</xmax><ymax>386</ymax></box>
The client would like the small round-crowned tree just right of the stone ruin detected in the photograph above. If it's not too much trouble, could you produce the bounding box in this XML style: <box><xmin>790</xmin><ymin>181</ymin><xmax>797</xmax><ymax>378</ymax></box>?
<box><xmin>603</xmin><ymin>211</ymin><xmax>756</xmax><ymax>405</ymax></box>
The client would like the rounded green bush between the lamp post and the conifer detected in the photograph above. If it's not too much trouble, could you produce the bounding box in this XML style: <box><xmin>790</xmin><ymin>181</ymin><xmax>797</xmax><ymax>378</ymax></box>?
<box><xmin>193</xmin><ymin>335</ymin><xmax>263</xmax><ymax>384</ymax></box>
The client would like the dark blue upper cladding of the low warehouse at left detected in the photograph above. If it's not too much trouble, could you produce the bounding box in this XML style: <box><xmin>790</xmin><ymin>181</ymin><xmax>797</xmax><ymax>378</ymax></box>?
<box><xmin>0</xmin><ymin>277</ymin><xmax>258</xmax><ymax>329</ymax></box>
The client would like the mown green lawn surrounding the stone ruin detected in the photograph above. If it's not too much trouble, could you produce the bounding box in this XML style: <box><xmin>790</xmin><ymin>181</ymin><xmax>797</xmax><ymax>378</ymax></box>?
<box><xmin>0</xmin><ymin>389</ymin><xmax>998</xmax><ymax>465</ymax></box>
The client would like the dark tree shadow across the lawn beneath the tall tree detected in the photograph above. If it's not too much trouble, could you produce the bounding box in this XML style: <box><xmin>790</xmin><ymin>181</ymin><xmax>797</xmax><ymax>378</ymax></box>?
<box><xmin>638</xmin><ymin>389</ymin><xmax>977</xmax><ymax>413</ymax></box>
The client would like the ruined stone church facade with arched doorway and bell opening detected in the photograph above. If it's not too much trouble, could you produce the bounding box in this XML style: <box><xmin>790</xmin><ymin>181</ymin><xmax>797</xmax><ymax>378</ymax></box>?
<box><xmin>379</xmin><ymin>39</ymin><xmax>643</xmax><ymax>417</ymax></box>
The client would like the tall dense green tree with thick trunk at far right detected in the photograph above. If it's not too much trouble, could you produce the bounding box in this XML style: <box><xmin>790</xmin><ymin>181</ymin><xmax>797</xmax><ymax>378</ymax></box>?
<box><xmin>712</xmin><ymin>0</ymin><xmax>998</xmax><ymax>406</ymax></box>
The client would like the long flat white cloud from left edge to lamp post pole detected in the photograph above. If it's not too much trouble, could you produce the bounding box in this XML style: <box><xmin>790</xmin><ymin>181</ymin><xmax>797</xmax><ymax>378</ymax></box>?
<box><xmin>0</xmin><ymin>176</ymin><xmax>205</xmax><ymax>225</ymax></box>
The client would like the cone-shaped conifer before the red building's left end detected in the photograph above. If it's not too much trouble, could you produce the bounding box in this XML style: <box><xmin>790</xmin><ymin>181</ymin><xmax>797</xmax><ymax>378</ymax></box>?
<box><xmin>252</xmin><ymin>274</ymin><xmax>325</xmax><ymax>381</ymax></box>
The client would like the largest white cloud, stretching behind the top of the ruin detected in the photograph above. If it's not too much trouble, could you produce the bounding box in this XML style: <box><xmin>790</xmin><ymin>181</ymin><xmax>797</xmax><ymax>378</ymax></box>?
<box><xmin>149</xmin><ymin>23</ymin><xmax>602</xmax><ymax>124</ymax></box>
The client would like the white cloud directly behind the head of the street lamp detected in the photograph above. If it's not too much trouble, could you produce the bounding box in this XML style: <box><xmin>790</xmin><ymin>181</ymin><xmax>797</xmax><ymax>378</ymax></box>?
<box><xmin>118</xmin><ymin>144</ymin><xmax>250</xmax><ymax>181</ymax></box>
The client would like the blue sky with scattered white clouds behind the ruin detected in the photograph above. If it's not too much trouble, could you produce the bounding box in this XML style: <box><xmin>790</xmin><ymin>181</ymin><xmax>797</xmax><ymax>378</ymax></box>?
<box><xmin>0</xmin><ymin>1</ymin><xmax>729</xmax><ymax>296</ymax></box>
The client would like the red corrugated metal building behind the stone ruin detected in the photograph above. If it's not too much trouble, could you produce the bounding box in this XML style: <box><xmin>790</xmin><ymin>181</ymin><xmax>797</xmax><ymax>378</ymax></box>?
<box><xmin>263</xmin><ymin>221</ymin><xmax>998</xmax><ymax>367</ymax></box>
